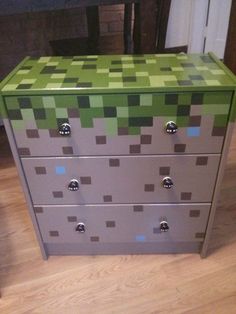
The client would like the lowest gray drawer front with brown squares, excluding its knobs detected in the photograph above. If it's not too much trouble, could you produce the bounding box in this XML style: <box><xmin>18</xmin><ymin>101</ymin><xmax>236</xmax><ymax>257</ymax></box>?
<box><xmin>35</xmin><ymin>204</ymin><xmax>210</xmax><ymax>244</ymax></box>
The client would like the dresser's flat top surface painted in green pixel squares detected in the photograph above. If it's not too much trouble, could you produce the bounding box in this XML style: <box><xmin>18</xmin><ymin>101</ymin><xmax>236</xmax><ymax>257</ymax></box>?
<box><xmin>2</xmin><ymin>53</ymin><xmax>235</xmax><ymax>94</ymax></box>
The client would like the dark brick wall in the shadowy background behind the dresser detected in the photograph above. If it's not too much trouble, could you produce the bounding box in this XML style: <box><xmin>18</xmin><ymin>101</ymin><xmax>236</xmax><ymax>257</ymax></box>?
<box><xmin>0</xmin><ymin>5</ymin><xmax>124</xmax><ymax>80</ymax></box>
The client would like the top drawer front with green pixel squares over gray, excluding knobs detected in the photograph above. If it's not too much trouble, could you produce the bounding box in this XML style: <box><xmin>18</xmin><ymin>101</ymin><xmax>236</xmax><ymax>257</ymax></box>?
<box><xmin>5</xmin><ymin>91</ymin><xmax>232</xmax><ymax>156</ymax></box>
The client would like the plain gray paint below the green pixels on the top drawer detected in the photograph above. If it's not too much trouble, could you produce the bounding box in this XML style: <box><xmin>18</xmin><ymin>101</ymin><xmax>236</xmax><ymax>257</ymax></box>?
<box><xmin>14</xmin><ymin>115</ymin><xmax>224</xmax><ymax>156</ymax></box>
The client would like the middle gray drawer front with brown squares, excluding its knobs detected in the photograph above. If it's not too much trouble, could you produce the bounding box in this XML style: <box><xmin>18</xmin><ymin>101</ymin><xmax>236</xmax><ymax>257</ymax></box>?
<box><xmin>22</xmin><ymin>155</ymin><xmax>220</xmax><ymax>204</ymax></box>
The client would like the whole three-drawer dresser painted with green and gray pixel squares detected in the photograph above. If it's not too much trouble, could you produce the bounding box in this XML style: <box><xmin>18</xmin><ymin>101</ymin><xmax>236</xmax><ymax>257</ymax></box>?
<box><xmin>1</xmin><ymin>54</ymin><xmax>235</xmax><ymax>258</ymax></box>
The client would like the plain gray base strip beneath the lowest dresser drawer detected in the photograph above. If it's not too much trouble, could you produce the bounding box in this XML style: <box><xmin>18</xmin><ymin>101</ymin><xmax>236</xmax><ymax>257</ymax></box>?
<box><xmin>45</xmin><ymin>242</ymin><xmax>202</xmax><ymax>255</ymax></box>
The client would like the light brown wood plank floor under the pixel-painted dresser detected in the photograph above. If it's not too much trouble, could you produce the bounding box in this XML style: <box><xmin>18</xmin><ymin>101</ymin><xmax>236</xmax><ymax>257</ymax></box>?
<box><xmin>0</xmin><ymin>129</ymin><xmax>236</xmax><ymax>314</ymax></box>
